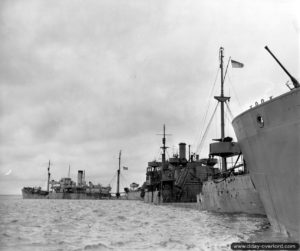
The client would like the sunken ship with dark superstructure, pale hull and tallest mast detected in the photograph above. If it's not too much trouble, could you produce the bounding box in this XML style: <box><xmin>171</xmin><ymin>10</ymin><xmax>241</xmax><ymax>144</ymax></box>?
<box><xmin>144</xmin><ymin>48</ymin><xmax>265</xmax><ymax>215</ymax></box>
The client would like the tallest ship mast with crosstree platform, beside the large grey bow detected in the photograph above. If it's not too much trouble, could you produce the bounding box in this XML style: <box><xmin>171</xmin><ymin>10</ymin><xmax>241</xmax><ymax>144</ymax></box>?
<box><xmin>214</xmin><ymin>47</ymin><xmax>230</xmax><ymax>171</ymax></box>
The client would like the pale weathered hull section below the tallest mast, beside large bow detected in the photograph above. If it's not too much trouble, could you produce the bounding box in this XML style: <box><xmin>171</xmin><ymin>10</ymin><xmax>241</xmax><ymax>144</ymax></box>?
<box><xmin>197</xmin><ymin>174</ymin><xmax>266</xmax><ymax>215</ymax></box>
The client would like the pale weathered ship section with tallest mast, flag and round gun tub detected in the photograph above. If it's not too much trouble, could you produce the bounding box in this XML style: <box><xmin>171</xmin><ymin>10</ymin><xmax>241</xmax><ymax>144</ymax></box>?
<box><xmin>197</xmin><ymin>47</ymin><xmax>266</xmax><ymax>215</ymax></box>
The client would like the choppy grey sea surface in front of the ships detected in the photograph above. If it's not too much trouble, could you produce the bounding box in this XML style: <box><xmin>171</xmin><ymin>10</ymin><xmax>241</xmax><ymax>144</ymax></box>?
<box><xmin>0</xmin><ymin>196</ymin><xmax>289</xmax><ymax>250</ymax></box>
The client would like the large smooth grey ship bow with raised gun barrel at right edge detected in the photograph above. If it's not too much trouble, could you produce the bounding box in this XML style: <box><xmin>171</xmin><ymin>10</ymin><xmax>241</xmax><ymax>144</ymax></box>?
<box><xmin>232</xmin><ymin>46</ymin><xmax>300</xmax><ymax>237</ymax></box>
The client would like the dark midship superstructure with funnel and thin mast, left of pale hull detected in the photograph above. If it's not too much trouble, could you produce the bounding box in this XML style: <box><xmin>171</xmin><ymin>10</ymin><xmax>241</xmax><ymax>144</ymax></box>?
<box><xmin>144</xmin><ymin>125</ymin><xmax>218</xmax><ymax>207</ymax></box>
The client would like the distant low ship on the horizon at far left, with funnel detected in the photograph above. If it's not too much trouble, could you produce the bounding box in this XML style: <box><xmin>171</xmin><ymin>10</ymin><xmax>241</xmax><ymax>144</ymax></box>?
<box><xmin>22</xmin><ymin>161</ymin><xmax>111</xmax><ymax>200</ymax></box>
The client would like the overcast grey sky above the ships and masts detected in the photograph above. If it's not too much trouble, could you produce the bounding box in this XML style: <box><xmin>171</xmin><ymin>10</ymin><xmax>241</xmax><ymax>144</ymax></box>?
<box><xmin>0</xmin><ymin>0</ymin><xmax>300</xmax><ymax>194</ymax></box>
